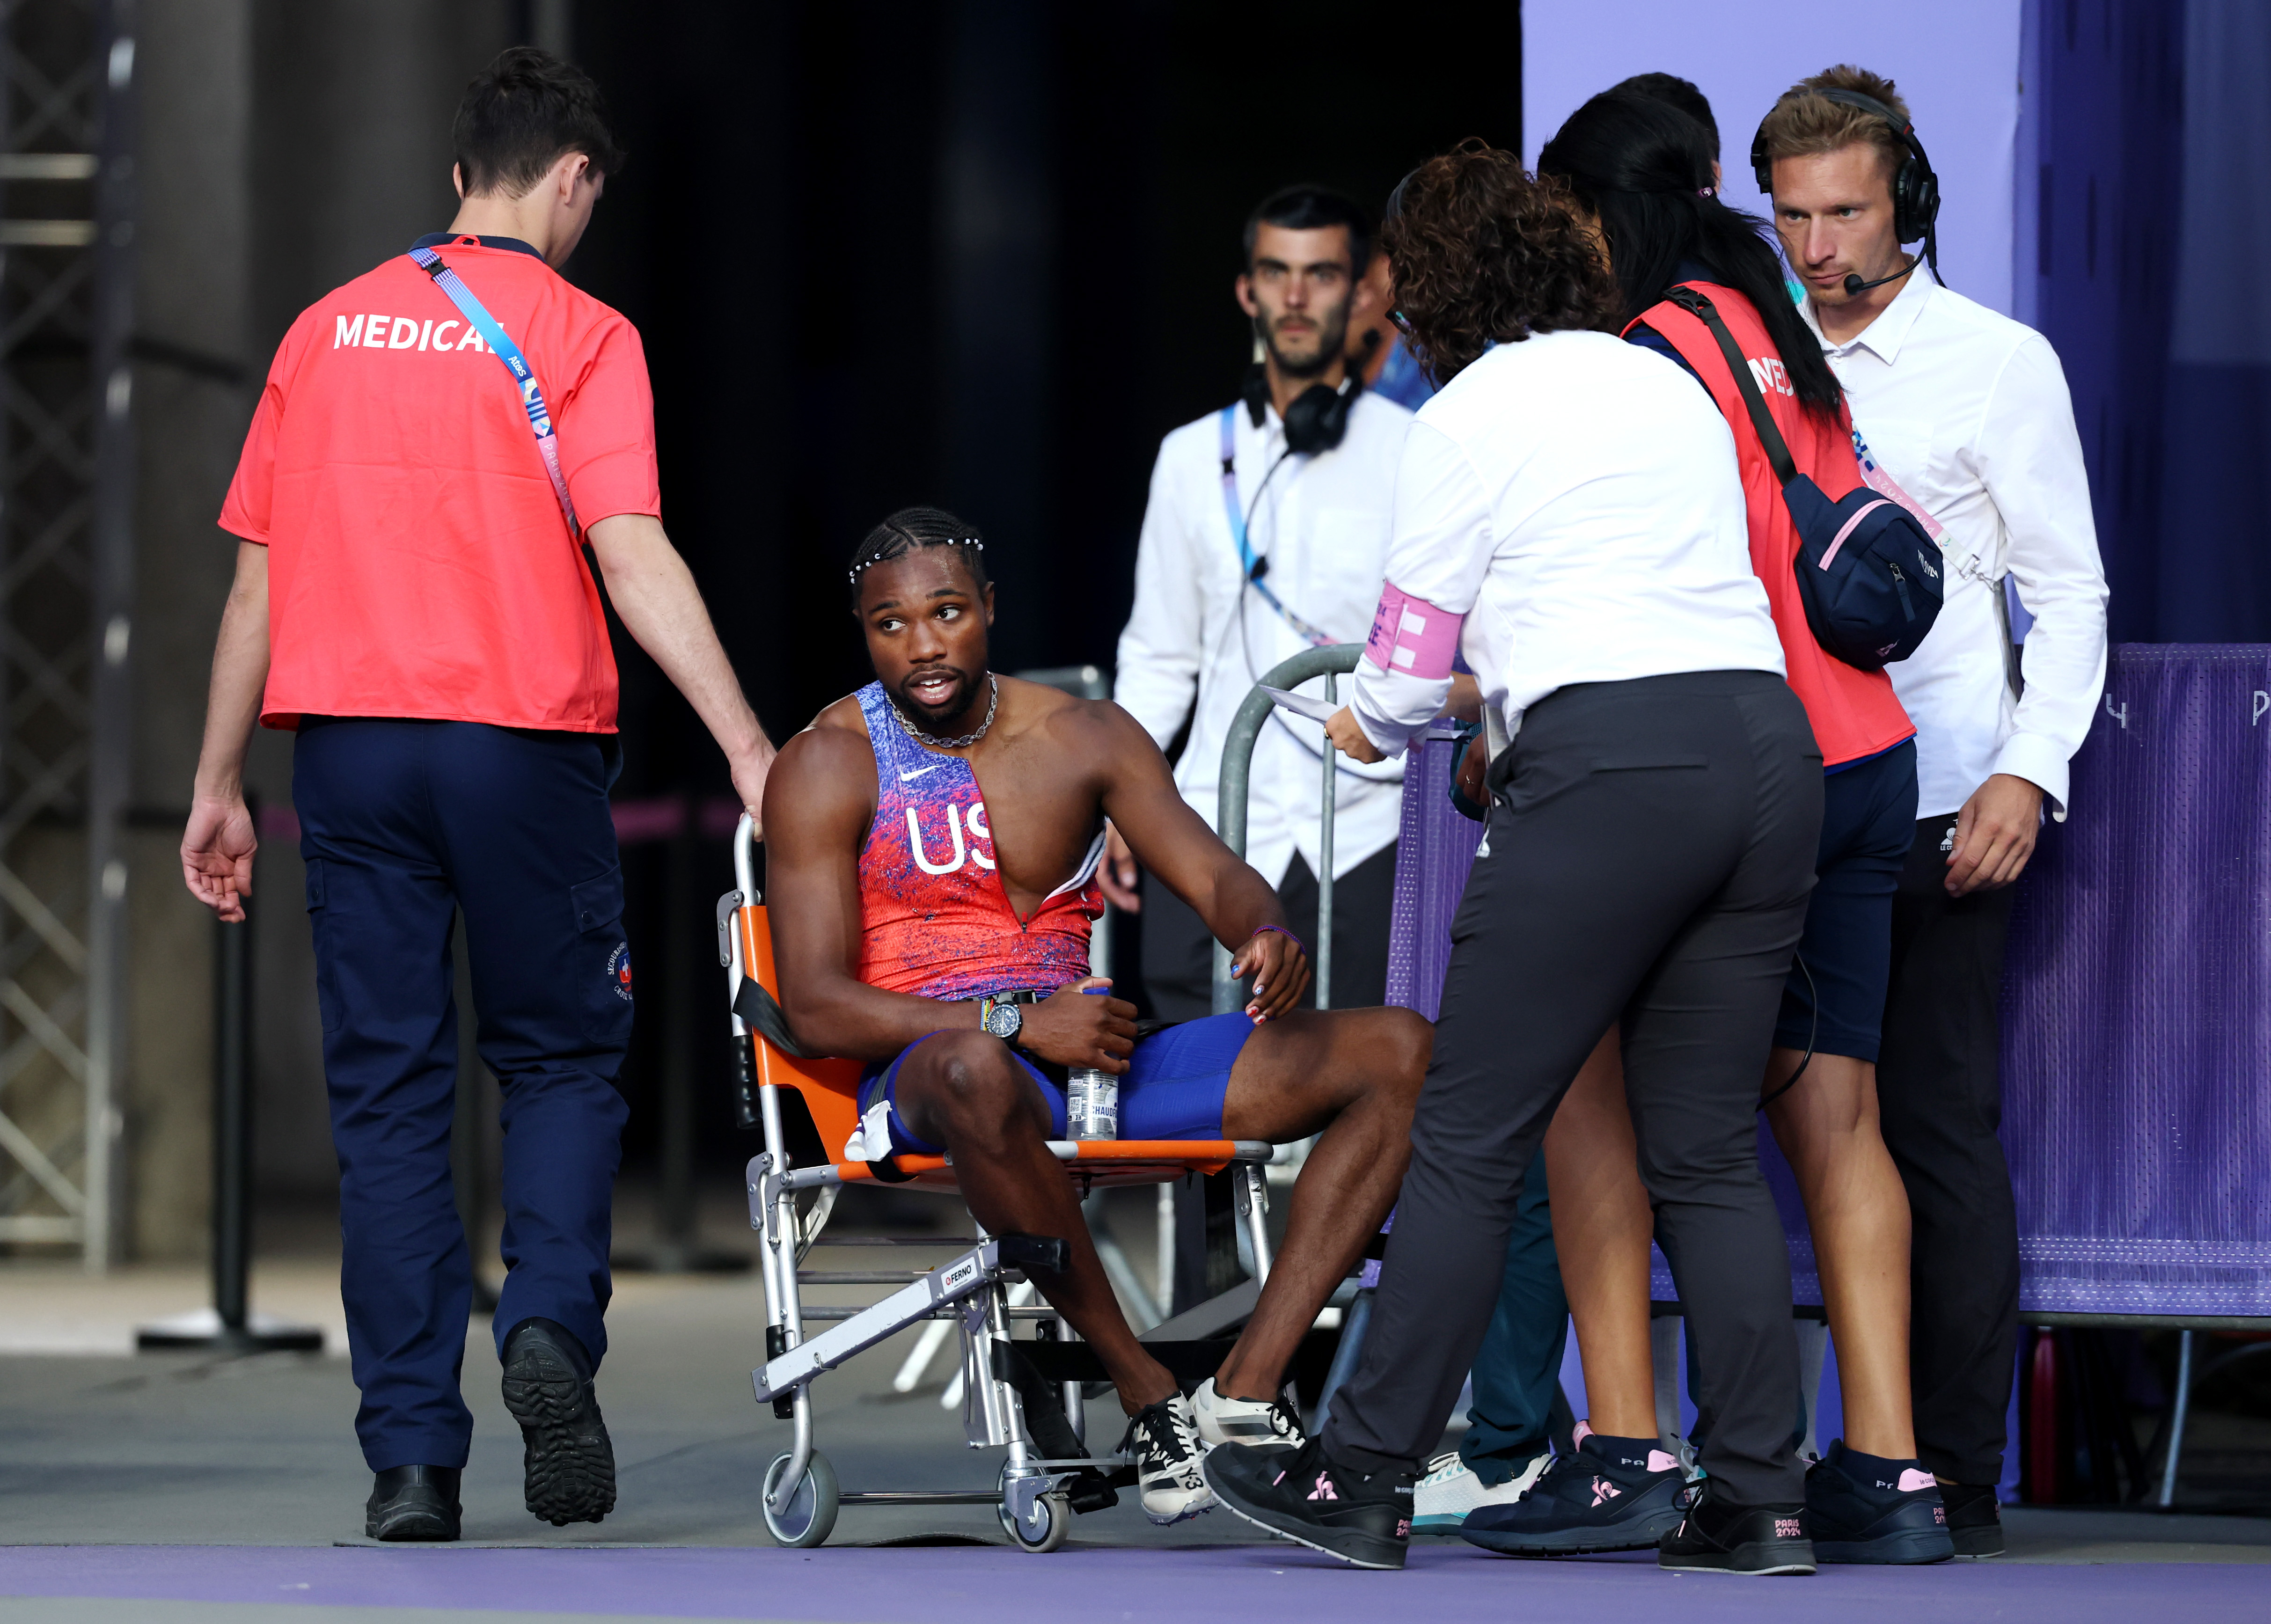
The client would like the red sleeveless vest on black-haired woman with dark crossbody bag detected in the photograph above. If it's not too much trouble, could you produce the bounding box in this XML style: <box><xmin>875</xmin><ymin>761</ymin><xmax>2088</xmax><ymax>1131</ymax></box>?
<box><xmin>1640</xmin><ymin>282</ymin><xmax>1917</xmax><ymax>768</ymax></box>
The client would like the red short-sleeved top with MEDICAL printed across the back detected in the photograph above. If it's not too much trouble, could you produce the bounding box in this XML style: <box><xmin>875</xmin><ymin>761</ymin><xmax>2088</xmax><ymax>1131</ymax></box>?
<box><xmin>220</xmin><ymin>236</ymin><xmax>661</xmax><ymax>734</ymax></box>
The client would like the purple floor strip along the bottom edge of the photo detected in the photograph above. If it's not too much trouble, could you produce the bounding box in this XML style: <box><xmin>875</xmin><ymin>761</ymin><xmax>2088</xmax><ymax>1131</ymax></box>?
<box><xmin>0</xmin><ymin>1544</ymin><xmax>2266</xmax><ymax>1624</ymax></box>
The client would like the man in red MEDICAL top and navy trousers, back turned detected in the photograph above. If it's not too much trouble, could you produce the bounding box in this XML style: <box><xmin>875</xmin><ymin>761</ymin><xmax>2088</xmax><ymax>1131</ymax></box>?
<box><xmin>182</xmin><ymin>48</ymin><xmax>772</xmax><ymax>1540</ymax></box>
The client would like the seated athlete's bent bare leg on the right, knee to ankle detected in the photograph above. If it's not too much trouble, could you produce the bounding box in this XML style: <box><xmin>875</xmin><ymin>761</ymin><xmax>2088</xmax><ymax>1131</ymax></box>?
<box><xmin>1215</xmin><ymin>1009</ymin><xmax>1435</xmax><ymax>1399</ymax></box>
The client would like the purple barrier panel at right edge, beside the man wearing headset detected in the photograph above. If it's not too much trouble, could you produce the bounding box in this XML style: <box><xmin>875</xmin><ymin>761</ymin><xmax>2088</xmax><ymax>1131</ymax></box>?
<box><xmin>2003</xmin><ymin>645</ymin><xmax>2271</xmax><ymax>1315</ymax></box>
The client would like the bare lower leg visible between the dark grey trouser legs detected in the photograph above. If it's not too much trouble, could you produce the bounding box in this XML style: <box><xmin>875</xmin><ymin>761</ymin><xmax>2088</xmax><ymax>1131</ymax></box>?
<box><xmin>1546</xmin><ymin>1029</ymin><xmax>1656</xmax><ymax>1438</ymax></box>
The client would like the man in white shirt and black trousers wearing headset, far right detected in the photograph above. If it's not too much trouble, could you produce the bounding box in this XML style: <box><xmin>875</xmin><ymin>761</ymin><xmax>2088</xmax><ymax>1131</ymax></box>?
<box><xmin>1751</xmin><ymin>66</ymin><xmax>2105</xmax><ymax>1556</ymax></box>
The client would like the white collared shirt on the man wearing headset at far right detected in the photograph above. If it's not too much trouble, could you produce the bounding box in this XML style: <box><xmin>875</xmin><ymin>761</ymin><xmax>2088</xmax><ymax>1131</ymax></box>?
<box><xmin>1803</xmin><ymin>271</ymin><xmax>2105</xmax><ymax>818</ymax></box>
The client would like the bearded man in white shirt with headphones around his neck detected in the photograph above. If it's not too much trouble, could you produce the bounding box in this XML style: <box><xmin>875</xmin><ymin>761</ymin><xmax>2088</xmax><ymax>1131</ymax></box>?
<box><xmin>1101</xmin><ymin>186</ymin><xmax>1413</xmax><ymax>1020</ymax></box>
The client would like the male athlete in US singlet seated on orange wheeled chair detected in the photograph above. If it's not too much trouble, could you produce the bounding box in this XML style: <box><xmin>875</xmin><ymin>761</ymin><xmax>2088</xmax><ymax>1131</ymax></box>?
<box><xmin>765</xmin><ymin>509</ymin><xmax>1433</xmax><ymax>1524</ymax></box>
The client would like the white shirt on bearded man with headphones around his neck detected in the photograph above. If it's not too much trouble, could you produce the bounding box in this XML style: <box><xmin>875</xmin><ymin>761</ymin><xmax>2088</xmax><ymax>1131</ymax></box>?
<box><xmin>1113</xmin><ymin>384</ymin><xmax>1408</xmax><ymax>886</ymax></box>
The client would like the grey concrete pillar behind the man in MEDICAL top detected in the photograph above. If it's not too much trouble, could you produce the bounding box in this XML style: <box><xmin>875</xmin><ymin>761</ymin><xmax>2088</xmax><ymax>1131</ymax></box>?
<box><xmin>123</xmin><ymin>0</ymin><xmax>513</xmax><ymax>1258</ymax></box>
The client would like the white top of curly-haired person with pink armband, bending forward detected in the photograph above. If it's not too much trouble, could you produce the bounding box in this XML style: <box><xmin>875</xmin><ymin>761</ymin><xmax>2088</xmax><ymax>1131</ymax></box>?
<box><xmin>1351</xmin><ymin>332</ymin><xmax>1783</xmax><ymax>754</ymax></box>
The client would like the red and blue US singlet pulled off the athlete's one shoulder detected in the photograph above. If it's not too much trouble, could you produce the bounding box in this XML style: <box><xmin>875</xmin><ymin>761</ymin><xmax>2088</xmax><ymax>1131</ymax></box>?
<box><xmin>858</xmin><ymin>681</ymin><xmax>1104</xmax><ymax>999</ymax></box>
